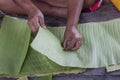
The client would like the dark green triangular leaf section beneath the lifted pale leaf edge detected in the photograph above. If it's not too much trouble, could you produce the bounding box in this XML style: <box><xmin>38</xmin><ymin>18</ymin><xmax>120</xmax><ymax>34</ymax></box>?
<box><xmin>20</xmin><ymin>48</ymin><xmax>85</xmax><ymax>76</ymax></box>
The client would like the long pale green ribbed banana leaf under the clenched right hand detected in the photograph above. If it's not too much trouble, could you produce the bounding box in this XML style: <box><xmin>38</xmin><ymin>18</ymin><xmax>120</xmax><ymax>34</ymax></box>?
<box><xmin>31</xmin><ymin>19</ymin><xmax>120</xmax><ymax>68</ymax></box>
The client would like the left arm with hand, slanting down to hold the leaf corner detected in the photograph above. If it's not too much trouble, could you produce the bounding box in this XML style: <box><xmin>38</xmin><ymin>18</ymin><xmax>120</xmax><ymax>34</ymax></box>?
<box><xmin>13</xmin><ymin>0</ymin><xmax>46</xmax><ymax>32</ymax></box>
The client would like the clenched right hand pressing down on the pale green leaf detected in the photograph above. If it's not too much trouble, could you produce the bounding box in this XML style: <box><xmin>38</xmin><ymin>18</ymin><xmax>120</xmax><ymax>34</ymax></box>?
<box><xmin>63</xmin><ymin>27</ymin><xmax>82</xmax><ymax>51</ymax></box>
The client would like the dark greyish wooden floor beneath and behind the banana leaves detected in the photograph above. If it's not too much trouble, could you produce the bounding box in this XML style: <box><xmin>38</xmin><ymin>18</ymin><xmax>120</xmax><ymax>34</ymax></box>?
<box><xmin>0</xmin><ymin>0</ymin><xmax>120</xmax><ymax>80</ymax></box>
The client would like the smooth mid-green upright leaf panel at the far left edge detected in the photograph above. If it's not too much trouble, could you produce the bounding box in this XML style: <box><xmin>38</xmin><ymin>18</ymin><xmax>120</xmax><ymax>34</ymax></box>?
<box><xmin>0</xmin><ymin>17</ymin><xmax>31</xmax><ymax>75</ymax></box>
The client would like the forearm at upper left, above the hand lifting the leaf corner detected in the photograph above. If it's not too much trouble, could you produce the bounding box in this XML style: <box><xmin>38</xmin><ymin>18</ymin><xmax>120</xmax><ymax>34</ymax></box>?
<box><xmin>13</xmin><ymin>0</ymin><xmax>38</xmax><ymax>14</ymax></box>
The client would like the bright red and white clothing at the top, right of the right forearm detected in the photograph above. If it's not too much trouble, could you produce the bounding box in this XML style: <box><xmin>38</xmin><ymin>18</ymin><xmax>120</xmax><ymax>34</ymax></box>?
<box><xmin>84</xmin><ymin>0</ymin><xmax>103</xmax><ymax>12</ymax></box>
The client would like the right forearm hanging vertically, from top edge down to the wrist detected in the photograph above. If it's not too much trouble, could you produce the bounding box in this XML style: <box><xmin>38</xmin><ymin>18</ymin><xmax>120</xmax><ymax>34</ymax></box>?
<box><xmin>67</xmin><ymin>0</ymin><xmax>84</xmax><ymax>28</ymax></box>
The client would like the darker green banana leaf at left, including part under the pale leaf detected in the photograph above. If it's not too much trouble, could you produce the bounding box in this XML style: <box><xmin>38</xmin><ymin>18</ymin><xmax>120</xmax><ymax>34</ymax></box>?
<box><xmin>0</xmin><ymin>16</ymin><xmax>85</xmax><ymax>77</ymax></box>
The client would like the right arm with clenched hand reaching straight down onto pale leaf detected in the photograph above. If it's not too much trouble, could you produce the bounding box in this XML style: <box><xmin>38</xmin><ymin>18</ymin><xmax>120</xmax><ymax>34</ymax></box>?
<box><xmin>63</xmin><ymin>0</ymin><xmax>84</xmax><ymax>50</ymax></box>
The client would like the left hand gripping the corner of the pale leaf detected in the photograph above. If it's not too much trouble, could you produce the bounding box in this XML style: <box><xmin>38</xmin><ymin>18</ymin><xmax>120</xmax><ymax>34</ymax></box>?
<box><xmin>28</xmin><ymin>10</ymin><xmax>46</xmax><ymax>32</ymax></box>
